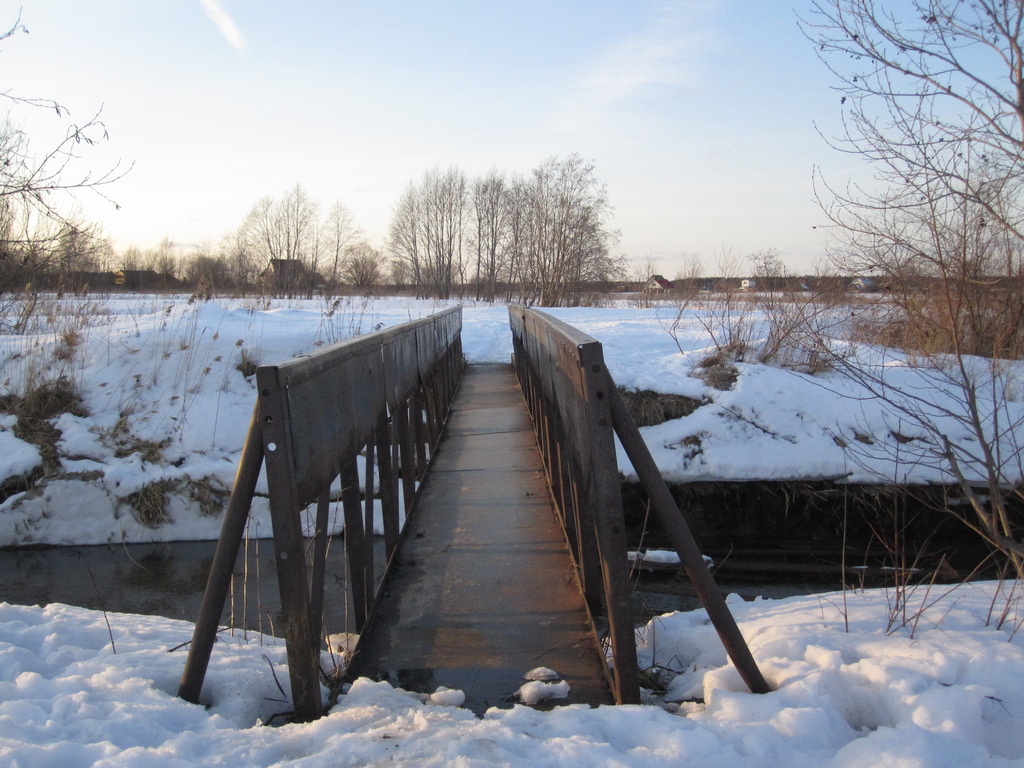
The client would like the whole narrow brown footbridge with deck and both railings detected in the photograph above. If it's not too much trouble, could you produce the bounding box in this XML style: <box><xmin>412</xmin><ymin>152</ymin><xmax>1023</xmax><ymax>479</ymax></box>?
<box><xmin>179</xmin><ymin>307</ymin><xmax>768</xmax><ymax>721</ymax></box>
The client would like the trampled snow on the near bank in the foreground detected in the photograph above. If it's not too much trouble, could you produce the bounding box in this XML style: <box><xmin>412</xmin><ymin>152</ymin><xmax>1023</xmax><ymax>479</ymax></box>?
<box><xmin>0</xmin><ymin>584</ymin><xmax>1024</xmax><ymax>768</ymax></box>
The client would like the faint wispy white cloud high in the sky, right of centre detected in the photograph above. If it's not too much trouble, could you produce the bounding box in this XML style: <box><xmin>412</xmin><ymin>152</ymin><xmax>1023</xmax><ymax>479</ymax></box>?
<box><xmin>558</xmin><ymin>0</ymin><xmax>718</xmax><ymax>125</ymax></box>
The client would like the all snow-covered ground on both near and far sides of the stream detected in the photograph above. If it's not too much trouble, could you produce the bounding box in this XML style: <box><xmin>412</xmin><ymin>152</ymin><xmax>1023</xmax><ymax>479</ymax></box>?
<box><xmin>0</xmin><ymin>297</ymin><xmax>1024</xmax><ymax>768</ymax></box>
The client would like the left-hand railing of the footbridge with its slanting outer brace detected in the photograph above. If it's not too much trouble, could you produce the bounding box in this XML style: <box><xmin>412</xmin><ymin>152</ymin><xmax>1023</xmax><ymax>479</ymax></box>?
<box><xmin>178</xmin><ymin>307</ymin><xmax>463</xmax><ymax>721</ymax></box>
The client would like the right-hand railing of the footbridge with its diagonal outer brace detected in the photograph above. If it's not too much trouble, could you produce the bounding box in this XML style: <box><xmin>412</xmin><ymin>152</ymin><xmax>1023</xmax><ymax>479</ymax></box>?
<box><xmin>509</xmin><ymin>306</ymin><xmax>769</xmax><ymax>703</ymax></box>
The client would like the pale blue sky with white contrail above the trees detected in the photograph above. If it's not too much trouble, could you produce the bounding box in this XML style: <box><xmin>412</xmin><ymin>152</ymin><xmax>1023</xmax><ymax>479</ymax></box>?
<box><xmin>6</xmin><ymin>0</ymin><xmax>858</xmax><ymax>278</ymax></box>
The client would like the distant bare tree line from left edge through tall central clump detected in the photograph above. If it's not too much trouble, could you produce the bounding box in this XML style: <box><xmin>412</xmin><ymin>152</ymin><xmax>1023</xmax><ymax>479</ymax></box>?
<box><xmin>6</xmin><ymin>155</ymin><xmax>625</xmax><ymax>306</ymax></box>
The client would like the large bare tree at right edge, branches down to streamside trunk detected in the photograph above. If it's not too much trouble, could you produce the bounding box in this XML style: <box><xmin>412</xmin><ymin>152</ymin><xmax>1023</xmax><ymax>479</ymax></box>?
<box><xmin>803</xmin><ymin>0</ymin><xmax>1024</xmax><ymax>575</ymax></box>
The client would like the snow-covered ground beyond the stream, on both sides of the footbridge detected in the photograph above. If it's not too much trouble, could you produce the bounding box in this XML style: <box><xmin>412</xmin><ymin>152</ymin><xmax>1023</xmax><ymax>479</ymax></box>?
<box><xmin>0</xmin><ymin>296</ymin><xmax>1024</xmax><ymax>546</ymax></box>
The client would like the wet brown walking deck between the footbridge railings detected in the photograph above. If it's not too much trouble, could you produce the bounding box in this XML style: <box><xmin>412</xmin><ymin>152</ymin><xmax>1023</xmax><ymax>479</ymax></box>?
<box><xmin>351</xmin><ymin>366</ymin><xmax>613</xmax><ymax>713</ymax></box>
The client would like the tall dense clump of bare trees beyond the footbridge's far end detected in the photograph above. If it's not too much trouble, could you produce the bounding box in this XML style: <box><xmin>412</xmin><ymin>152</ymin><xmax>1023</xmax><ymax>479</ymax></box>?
<box><xmin>388</xmin><ymin>155</ymin><xmax>624</xmax><ymax>306</ymax></box>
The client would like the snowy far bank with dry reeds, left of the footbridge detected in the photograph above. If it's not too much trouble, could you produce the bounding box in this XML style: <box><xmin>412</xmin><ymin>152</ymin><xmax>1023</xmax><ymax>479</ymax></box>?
<box><xmin>0</xmin><ymin>297</ymin><xmax>511</xmax><ymax>547</ymax></box>
